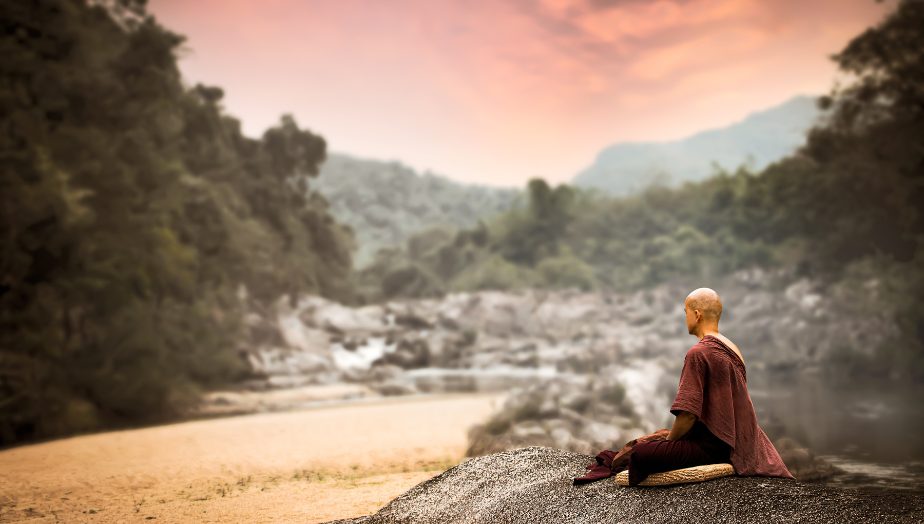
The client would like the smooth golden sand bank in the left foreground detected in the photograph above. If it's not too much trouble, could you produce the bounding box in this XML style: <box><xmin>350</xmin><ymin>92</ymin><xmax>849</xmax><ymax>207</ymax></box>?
<box><xmin>0</xmin><ymin>394</ymin><xmax>503</xmax><ymax>523</ymax></box>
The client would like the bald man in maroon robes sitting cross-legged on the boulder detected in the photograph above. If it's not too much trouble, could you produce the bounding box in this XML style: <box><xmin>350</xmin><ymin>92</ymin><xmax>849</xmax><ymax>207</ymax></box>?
<box><xmin>628</xmin><ymin>288</ymin><xmax>793</xmax><ymax>486</ymax></box>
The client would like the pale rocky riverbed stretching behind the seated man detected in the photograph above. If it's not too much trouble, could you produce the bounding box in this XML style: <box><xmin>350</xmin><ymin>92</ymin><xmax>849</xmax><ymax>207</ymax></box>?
<box><xmin>197</xmin><ymin>271</ymin><xmax>908</xmax><ymax>492</ymax></box>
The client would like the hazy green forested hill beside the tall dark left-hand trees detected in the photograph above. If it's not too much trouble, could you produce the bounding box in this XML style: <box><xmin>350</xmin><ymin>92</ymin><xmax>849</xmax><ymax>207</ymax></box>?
<box><xmin>311</xmin><ymin>153</ymin><xmax>522</xmax><ymax>268</ymax></box>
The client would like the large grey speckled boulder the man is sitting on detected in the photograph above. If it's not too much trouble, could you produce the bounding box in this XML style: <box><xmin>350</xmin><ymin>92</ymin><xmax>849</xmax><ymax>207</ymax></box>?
<box><xmin>324</xmin><ymin>446</ymin><xmax>924</xmax><ymax>524</ymax></box>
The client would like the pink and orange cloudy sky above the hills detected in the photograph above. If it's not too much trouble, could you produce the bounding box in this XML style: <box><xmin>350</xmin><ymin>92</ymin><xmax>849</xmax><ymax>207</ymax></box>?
<box><xmin>148</xmin><ymin>0</ymin><xmax>895</xmax><ymax>187</ymax></box>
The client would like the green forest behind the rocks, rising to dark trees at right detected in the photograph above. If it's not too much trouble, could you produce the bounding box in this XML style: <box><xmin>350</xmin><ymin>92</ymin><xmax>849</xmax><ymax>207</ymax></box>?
<box><xmin>360</xmin><ymin>1</ymin><xmax>924</xmax><ymax>379</ymax></box>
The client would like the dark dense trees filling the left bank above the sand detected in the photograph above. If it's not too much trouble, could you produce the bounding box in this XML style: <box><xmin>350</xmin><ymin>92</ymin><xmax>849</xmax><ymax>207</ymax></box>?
<box><xmin>0</xmin><ymin>0</ymin><xmax>354</xmax><ymax>444</ymax></box>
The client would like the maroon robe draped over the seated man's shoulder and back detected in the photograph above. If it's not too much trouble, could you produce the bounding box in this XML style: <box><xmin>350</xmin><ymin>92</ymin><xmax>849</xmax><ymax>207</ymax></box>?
<box><xmin>671</xmin><ymin>335</ymin><xmax>793</xmax><ymax>479</ymax></box>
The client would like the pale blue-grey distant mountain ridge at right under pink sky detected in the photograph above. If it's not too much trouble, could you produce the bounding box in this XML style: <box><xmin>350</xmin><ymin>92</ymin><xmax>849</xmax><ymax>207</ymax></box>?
<box><xmin>572</xmin><ymin>96</ymin><xmax>821</xmax><ymax>195</ymax></box>
